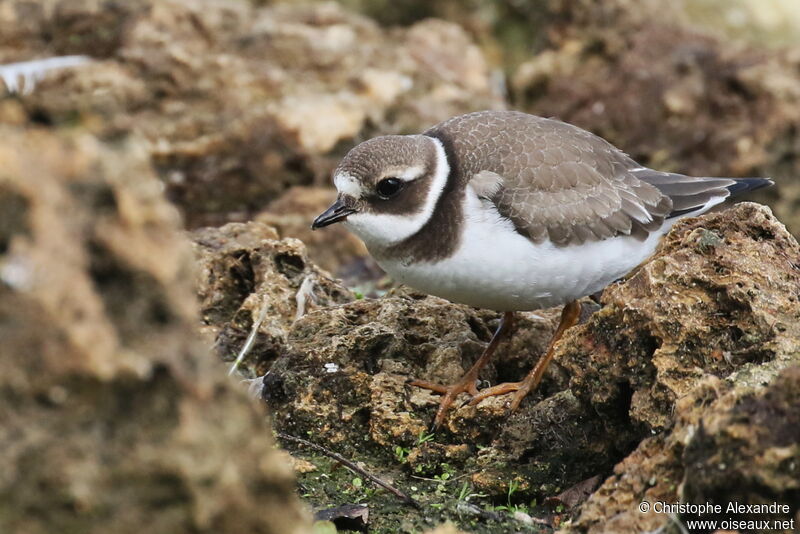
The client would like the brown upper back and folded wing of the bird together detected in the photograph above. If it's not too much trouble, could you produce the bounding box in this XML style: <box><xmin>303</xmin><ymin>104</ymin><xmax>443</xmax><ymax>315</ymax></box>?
<box><xmin>426</xmin><ymin>111</ymin><xmax>673</xmax><ymax>245</ymax></box>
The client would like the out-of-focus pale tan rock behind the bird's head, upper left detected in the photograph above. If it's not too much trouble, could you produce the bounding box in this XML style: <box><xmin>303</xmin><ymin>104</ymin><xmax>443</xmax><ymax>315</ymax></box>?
<box><xmin>0</xmin><ymin>0</ymin><xmax>502</xmax><ymax>226</ymax></box>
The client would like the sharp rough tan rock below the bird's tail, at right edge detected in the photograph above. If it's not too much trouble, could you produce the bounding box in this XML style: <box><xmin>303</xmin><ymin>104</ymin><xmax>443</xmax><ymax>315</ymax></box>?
<box><xmin>559</xmin><ymin>203</ymin><xmax>800</xmax><ymax>432</ymax></box>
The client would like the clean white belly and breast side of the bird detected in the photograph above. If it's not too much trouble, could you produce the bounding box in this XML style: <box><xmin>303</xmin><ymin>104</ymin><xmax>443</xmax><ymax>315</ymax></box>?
<box><xmin>376</xmin><ymin>194</ymin><xmax>674</xmax><ymax>311</ymax></box>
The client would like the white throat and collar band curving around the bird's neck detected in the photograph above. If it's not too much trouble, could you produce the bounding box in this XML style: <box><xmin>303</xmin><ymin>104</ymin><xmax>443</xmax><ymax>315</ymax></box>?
<box><xmin>336</xmin><ymin>137</ymin><xmax>450</xmax><ymax>251</ymax></box>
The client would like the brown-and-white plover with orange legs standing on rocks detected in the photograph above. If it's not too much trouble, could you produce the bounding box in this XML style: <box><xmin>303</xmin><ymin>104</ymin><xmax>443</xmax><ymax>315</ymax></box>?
<box><xmin>311</xmin><ymin>110</ymin><xmax>773</xmax><ymax>427</ymax></box>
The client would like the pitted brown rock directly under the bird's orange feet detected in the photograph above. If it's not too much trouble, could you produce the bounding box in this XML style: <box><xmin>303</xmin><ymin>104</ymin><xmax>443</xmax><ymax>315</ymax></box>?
<box><xmin>264</xmin><ymin>284</ymin><xmax>624</xmax><ymax>502</ymax></box>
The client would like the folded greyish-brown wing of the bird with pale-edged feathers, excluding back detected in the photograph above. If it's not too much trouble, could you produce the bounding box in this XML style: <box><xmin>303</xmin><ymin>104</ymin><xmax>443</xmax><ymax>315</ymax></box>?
<box><xmin>493</xmin><ymin>119</ymin><xmax>672</xmax><ymax>245</ymax></box>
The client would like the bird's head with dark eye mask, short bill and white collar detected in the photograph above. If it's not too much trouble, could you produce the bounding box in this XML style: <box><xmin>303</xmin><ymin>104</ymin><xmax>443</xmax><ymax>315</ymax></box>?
<box><xmin>311</xmin><ymin>135</ymin><xmax>450</xmax><ymax>248</ymax></box>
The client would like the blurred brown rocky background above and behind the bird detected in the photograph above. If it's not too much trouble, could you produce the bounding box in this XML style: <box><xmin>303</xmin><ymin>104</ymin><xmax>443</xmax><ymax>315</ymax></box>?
<box><xmin>0</xmin><ymin>0</ymin><xmax>800</xmax><ymax>282</ymax></box>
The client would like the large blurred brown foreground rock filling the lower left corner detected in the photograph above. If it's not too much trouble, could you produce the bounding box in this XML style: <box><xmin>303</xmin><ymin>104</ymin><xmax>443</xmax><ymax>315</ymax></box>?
<box><xmin>0</xmin><ymin>126</ymin><xmax>309</xmax><ymax>534</ymax></box>
